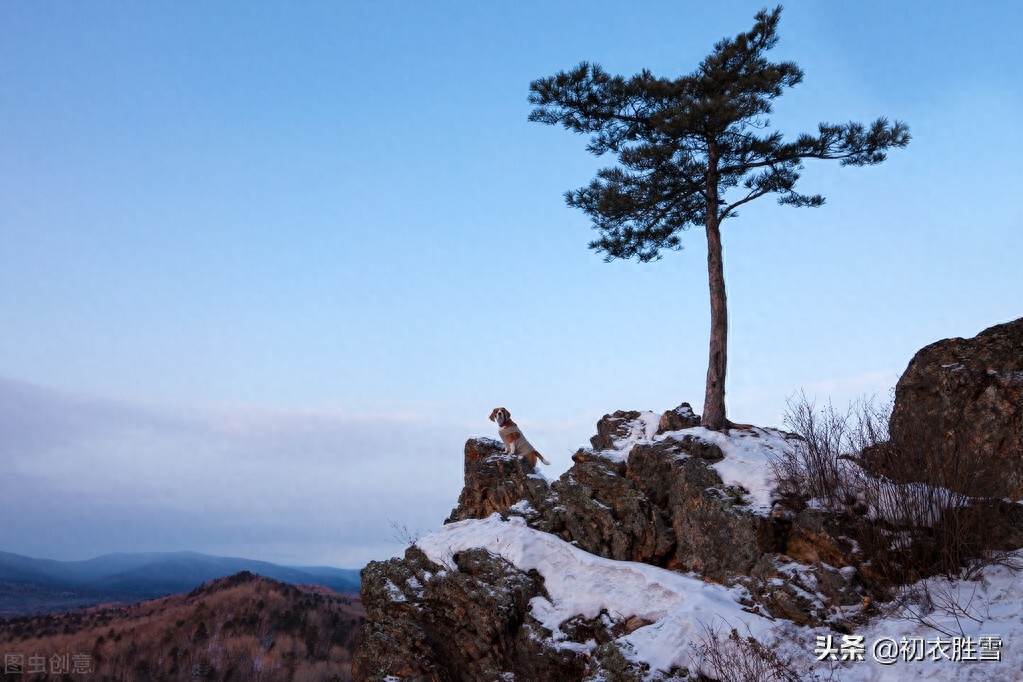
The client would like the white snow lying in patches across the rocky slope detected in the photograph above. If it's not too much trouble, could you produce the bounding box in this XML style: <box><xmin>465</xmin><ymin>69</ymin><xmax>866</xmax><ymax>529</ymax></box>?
<box><xmin>415</xmin><ymin>423</ymin><xmax>1023</xmax><ymax>682</ymax></box>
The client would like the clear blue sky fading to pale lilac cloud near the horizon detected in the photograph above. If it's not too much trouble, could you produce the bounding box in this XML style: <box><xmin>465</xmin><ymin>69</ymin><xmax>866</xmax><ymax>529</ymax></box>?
<box><xmin>0</xmin><ymin>0</ymin><xmax>1023</xmax><ymax>567</ymax></box>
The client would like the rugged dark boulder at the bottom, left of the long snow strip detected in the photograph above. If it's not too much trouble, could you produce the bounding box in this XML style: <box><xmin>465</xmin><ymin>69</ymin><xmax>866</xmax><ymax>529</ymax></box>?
<box><xmin>352</xmin><ymin>547</ymin><xmax>584</xmax><ymax>682</ymax></box>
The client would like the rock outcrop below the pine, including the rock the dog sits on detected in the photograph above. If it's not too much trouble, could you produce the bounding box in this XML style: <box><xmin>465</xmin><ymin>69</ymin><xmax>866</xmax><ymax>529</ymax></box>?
<box><xmin>445</xmin><ymin>421</ymin><xmax>780</xmax><ymax>581</ymax></box>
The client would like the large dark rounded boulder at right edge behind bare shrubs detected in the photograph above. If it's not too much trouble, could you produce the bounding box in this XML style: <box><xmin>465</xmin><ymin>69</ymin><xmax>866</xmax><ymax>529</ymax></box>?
<box><xmin>889</xmin><ymin>318</ymin><xmax>1023</xmax><ymax>500</ymax></box>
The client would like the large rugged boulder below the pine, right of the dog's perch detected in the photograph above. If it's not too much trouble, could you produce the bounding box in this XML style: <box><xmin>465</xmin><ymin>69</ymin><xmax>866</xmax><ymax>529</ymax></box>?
<box><xmin>568</xmin><ymin>411</ymin><xmax>787</xmax><ymax>581</ymax></box>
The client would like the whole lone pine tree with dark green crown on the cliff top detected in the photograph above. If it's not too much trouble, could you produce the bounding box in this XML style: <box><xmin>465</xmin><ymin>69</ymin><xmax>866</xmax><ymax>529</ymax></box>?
<box><xmin>529</xmin><ymin>6</ymin><xmax>909</xmax><ymax>430</ymax></box>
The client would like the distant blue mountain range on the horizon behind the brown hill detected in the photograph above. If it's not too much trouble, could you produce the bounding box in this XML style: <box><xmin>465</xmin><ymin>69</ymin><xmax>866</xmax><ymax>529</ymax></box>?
<box><xmin>0</xmin><ymin>552</ymin><xmax>359</xmax><ymax>618</ymax></box>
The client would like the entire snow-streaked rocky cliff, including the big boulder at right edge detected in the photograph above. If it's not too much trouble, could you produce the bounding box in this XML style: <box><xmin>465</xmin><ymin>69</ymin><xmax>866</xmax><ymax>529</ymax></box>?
<box><xmin>353</xmin><ymin>320</ymin><xmax>1023</xmax><ymax>682</ymax></box>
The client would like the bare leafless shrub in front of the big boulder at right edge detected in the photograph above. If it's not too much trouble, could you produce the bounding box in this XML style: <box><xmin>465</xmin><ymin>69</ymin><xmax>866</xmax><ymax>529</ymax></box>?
<box><xmin>772</xmin><ymin>392</ymin><xmax>1020</xmax><ymax>599</ymax></box>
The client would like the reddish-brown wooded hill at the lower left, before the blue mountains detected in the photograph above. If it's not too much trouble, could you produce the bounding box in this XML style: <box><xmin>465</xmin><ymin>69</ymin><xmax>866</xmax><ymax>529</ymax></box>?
<box><xmin>0</xmin><ymin>572</ymin><xmax>365</xmax><ymax>682</ymax></box>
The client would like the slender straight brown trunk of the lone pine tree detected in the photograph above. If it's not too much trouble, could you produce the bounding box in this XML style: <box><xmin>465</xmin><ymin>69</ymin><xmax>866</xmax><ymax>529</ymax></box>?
<box><xmin>700</xmin><ymin>143</ymin><xmax>728</xmax><ymax>431</ymax></box>
